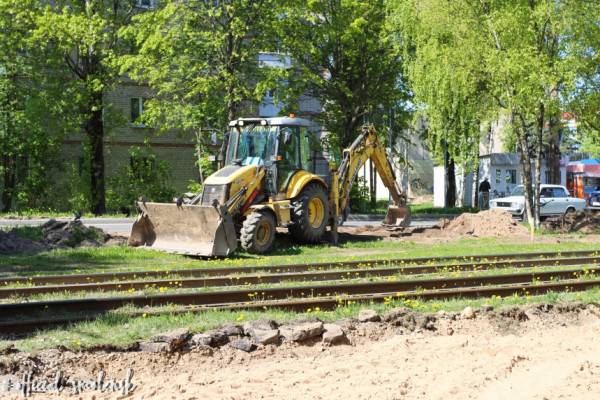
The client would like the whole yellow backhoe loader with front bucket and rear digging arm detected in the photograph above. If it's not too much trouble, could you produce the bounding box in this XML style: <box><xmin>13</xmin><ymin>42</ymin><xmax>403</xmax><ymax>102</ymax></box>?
<box><xmin>129</xmin><ymin>117</ymin><xmax>410</xmax><ymax>256</ymax></box>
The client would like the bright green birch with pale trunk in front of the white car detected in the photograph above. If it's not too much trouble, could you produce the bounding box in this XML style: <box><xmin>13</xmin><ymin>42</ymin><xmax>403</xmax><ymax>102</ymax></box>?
<box><xmin>397</xmin><ymin>0</ymin><xmax>600</xmax><ymax>229</ymax></box>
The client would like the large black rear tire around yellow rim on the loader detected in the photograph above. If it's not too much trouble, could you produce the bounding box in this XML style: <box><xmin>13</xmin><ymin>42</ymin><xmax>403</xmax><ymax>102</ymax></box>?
<box><xmin>289</xmin><ymin>183</ymin><xmax>329</xmax><ymax>243</ymax></box>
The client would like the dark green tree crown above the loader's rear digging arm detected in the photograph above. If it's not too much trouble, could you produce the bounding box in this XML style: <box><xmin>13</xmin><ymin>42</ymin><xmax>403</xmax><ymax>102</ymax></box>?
<box><xmin>280</xmin><ymin>0</ymin><xmax>405</xmax><ymax>149</ymax></box>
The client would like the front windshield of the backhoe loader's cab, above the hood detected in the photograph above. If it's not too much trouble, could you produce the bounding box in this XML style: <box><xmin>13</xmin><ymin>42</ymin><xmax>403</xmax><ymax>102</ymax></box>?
<box><xmin>226</xmin><ymin>125</ymin><xmax>277</xmax><ymax>165</ymax></box>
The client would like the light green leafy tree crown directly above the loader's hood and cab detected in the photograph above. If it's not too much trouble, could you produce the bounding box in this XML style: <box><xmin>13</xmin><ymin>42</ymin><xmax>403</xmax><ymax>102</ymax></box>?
<box><xmin>120</xmin><ymin>0</ymin><xmax>277</xmax><ymax>143</ymax></box>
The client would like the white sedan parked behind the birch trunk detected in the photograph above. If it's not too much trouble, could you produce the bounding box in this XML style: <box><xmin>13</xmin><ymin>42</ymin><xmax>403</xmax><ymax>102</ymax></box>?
<box><xmin>490</xmin><ymin>185</ymin><xmax>586</xmax><ymax>218</ymax></box>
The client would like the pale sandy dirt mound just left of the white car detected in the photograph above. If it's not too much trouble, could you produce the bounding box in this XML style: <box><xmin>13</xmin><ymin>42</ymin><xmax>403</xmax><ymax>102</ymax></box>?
<box><xmin>441</xmin><ymin>209</ymin><xmax>528</xmax><ymax>237</ymax></box>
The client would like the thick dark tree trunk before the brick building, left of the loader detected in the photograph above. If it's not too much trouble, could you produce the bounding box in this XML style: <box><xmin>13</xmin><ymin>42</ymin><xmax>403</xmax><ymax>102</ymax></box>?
<box><xmin>85</xmin><ymin>91</ymin><xmax>106</xmax><ymax>215</ymax></box>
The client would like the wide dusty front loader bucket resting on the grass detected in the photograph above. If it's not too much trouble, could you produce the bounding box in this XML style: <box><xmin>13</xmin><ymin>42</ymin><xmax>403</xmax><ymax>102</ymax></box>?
<box><xmin>128</xmin><ymin>202</ymin><xmax>237</xmax><ymax>256</ymax></box>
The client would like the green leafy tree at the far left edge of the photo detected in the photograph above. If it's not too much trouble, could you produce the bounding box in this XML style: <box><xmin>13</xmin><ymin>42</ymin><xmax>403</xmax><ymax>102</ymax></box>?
<box><xmin>0</xmin><ymin>0</ymin><xmax>70</xmax><ymax>211</ymax></box>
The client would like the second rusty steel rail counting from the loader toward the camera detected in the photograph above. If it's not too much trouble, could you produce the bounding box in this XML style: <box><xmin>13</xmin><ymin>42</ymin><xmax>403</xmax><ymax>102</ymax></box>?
<box><xmin>0</xmin><ymin>257</ymin><xmax>600</xmax><ymax>299</ymax></box>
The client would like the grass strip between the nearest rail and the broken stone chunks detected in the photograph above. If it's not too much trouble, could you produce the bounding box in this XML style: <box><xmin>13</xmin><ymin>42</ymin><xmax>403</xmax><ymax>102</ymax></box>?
<box><xmin>0</xmin><ymin>288</ymin><xmax>600</xmax><ymax>352</ymax></box>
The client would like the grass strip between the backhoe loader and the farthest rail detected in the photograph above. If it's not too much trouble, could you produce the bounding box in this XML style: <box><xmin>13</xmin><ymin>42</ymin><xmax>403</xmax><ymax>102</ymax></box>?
<box><xmin>0</xmin><ymin>235</ymin><xmax>598</xmax><ymax>278</ymax></box>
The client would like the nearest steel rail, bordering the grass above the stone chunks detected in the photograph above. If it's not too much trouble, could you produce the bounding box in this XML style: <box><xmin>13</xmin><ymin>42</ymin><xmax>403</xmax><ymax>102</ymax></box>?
<box><xmin>0</xmin><ymin>279</ymin><xmax>600</xmax><ymax>334</ymax></box>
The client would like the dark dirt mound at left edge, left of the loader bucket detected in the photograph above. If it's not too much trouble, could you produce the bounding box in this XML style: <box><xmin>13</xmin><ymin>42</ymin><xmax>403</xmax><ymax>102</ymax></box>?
<box><xmin>0</xmin><ymin>219</ymin><xmax>126</xmax><ymax>254</ymax></box>
